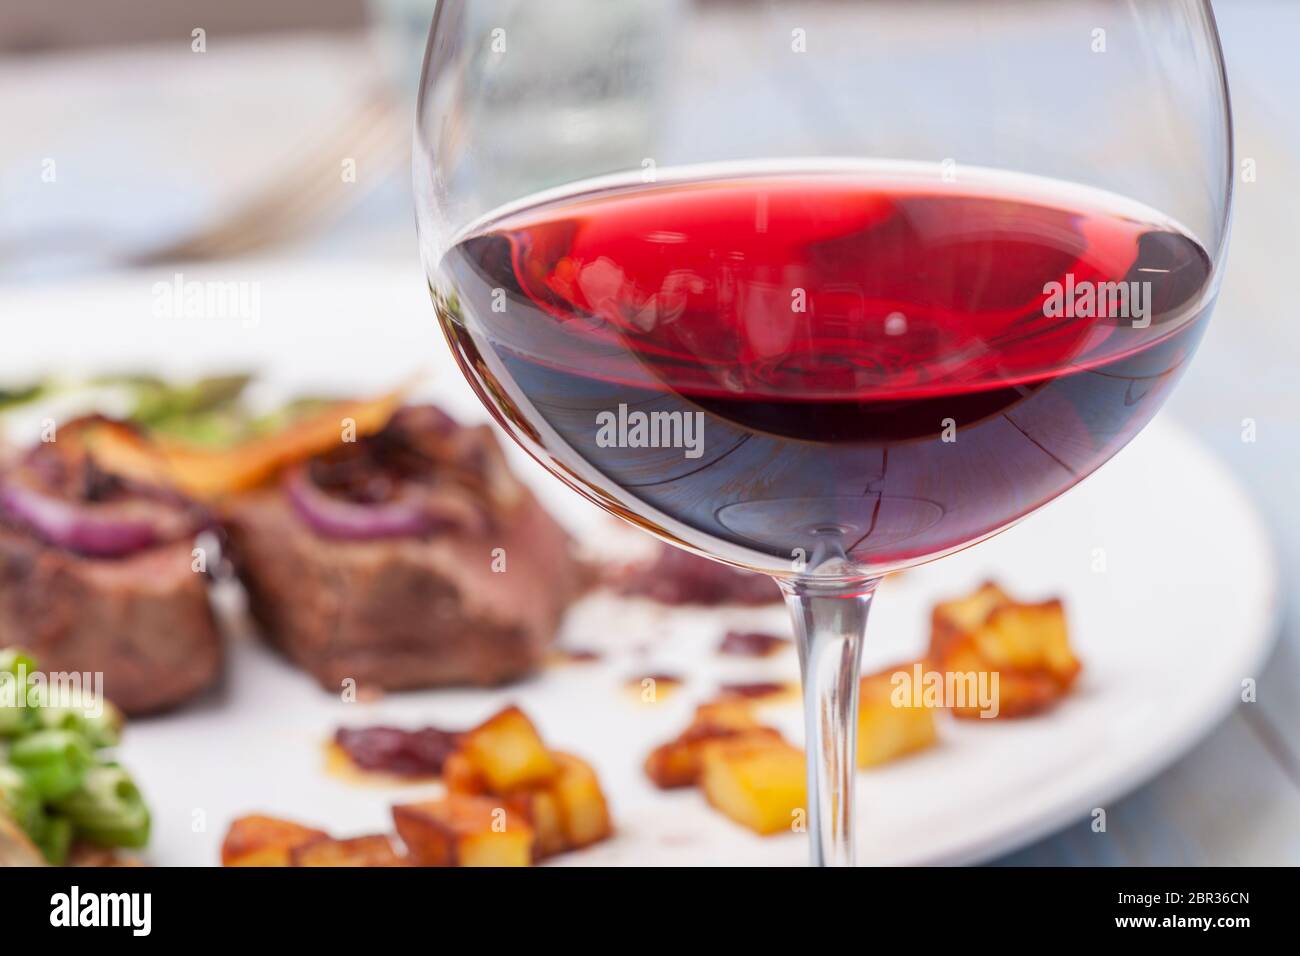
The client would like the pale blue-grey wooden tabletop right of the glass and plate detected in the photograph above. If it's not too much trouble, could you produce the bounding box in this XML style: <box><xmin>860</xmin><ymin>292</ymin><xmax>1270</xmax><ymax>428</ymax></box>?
<box><xmin>998</xmin><ymin>0</ymin><xmax>1300</xmax><ymax>865</ymax></box>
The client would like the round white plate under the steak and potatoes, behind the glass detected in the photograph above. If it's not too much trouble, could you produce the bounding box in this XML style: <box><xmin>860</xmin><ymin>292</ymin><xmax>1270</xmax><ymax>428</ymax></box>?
<box><xmin>0</xmin><ymin>267</ymin><xmax>1278</xmax><ymax>865</ymax></box>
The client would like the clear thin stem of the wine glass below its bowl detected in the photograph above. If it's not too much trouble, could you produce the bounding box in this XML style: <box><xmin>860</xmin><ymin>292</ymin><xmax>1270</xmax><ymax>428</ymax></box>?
<box><xmin>780</xmin><ymin>580</ymin><xmax>876</xmax><ymax>866</ymax></box>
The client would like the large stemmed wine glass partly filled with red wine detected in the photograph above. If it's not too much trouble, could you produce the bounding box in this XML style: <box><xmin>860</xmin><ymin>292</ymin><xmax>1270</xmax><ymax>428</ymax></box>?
<box><xmin>415</xmin><ymin>0</ymin><xmax>1234</xmax><ymax>864</ymax></box>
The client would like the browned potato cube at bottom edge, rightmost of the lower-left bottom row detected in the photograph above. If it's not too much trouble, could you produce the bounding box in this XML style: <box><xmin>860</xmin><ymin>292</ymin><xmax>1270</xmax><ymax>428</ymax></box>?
<box><xmin>393</xmin><ymin>793</ymin><xmax>534</xmax><ymax>866</ymax></box>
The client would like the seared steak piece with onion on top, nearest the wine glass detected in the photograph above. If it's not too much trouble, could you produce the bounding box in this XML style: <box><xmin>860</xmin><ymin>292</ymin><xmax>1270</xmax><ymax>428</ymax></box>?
<box><xmin>224</xmin><ymin>407</ymin><xmax>585</xmax><ymax>691</ymax></box>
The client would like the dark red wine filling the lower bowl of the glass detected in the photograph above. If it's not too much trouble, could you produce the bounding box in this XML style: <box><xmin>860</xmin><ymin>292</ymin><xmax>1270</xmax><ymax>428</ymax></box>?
<box><xmin>432</xmin><ymin>166</ymin><xmax>1213</xmax><ymax>572</ymax></box>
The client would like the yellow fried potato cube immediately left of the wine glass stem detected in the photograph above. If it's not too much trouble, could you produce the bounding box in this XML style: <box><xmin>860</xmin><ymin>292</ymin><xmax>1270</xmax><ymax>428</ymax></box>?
<box><xmin>701</xmin><ymin>736</ymin><xmax>807</xmax><ymax>835</ymax></box>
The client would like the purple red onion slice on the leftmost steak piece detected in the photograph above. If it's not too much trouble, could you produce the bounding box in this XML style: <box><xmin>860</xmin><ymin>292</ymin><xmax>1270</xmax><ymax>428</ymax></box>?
<box><xmin>0</xmin><ymin>480</ymin><xmax>160</xmax><ymax>558</ymax></box>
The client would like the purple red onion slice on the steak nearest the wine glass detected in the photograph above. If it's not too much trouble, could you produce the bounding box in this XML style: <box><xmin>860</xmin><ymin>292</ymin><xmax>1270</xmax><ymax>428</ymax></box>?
<box><xmin>285</xmin><ymin>464</ymin><xmax>473</xmax><ymax>541</ymax></box>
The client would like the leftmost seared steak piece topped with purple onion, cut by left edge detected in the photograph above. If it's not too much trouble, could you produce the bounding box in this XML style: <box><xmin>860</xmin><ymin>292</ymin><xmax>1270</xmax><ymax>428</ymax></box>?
<box><xmin>0</xmin><ymin>425</ymin><xmax>221</xmax><ymax>714</ymax></box>
